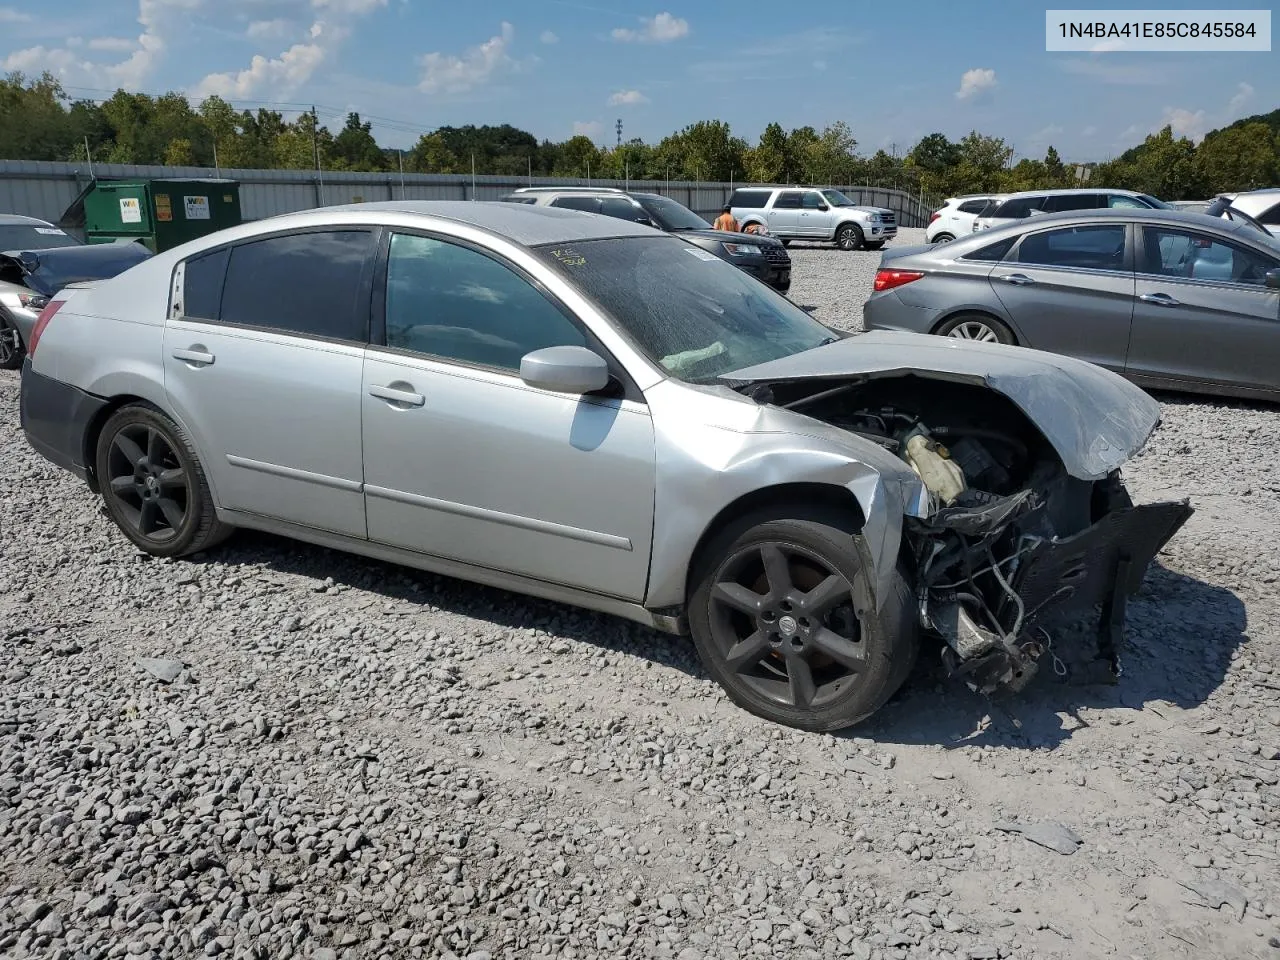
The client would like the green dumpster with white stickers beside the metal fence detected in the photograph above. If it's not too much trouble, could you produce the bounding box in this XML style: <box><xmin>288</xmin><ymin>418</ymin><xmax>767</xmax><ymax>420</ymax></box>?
<box><xmin>59</xmin><ymin>179</ymin><xmax>241</xmax><ymax>253</ymax></box>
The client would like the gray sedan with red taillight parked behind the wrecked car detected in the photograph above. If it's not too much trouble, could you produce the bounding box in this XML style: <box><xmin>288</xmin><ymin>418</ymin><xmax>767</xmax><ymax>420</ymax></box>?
<box><xmin>863</xmin><ymin>210</ymin><xmax>1280</xmax><ymax>399</ymax></box>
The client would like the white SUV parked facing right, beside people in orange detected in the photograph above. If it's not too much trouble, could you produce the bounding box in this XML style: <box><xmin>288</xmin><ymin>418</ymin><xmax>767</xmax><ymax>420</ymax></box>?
<box><xmin>728</xmin><ymin>187</ymin><xmax>897</xmax><ymax>250</ymax></box>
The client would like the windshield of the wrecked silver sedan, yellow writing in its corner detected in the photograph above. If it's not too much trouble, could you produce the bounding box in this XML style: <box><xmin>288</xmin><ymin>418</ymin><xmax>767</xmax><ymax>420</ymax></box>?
<box><xmin>536</xmin><ymin>237</ymin><xmax>837</xmax><ymax>383</ymax></box>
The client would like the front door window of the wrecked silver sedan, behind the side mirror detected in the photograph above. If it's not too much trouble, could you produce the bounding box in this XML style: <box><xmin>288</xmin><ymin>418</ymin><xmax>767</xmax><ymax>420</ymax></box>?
<box><xmin>387</xmin><ymin>233</ymin><xmax>586</xmax><ymax>371</ymax></box>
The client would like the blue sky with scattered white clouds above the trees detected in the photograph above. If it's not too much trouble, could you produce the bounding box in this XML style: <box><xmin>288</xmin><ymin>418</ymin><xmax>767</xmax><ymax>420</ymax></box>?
<box><xmin>0</xmin><ymin>0</ymin><xmax>1280</xmax><ymax>161</ymax></box>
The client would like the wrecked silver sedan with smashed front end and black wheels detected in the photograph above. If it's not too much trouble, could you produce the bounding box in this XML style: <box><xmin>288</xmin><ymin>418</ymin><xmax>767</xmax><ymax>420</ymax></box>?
<box><xmin>22</xmin><ymin>202</ymin><xmax>1190</xmax><ymax>730</ymax></box>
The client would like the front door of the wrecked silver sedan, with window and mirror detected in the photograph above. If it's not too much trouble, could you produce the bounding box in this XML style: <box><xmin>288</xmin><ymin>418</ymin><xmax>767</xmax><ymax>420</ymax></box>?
<box><xmin>362</xmin><ymin>233</ymin><xmax>655</xmax><ymax>600</ymax></box>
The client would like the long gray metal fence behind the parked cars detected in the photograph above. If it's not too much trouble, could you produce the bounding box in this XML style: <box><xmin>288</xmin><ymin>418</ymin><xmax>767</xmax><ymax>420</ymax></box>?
<box><xmin>0</xmin><ymin>160</ymin><xmax>934</xmax><ymax>227</ymax></box>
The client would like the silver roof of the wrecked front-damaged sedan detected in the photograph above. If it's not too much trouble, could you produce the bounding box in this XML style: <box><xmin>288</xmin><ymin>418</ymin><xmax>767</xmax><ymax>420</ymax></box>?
<box><xmin>268</xmin><ymin>200</ymin><xmax>655</xmax><ymax>247</ymax></box>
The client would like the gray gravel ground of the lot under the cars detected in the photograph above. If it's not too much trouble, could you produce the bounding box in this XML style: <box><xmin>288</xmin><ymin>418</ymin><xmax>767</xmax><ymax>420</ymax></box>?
<box><xmin>0</xmin><ymin>230</ymin><xmax>1280</xmax><ymax>960</ymax></box>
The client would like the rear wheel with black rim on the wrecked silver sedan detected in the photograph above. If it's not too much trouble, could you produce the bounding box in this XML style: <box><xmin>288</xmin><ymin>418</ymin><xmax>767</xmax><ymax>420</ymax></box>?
<box><xmin>96</xmin><ymin>404</ymin><xmax>232</xmax><ymax>557</ymax></box>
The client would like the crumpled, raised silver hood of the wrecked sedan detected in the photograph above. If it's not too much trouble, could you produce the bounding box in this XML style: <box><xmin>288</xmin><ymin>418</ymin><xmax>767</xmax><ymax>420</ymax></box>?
<box><xmin>723</xmin><ymin>330</ymin><xmax>1160</xmax><ymax>480</ymax></box>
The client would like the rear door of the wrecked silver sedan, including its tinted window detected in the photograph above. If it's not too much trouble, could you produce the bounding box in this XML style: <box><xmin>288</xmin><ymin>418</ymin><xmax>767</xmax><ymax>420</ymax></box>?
<box><xmin>156</xmin><ymin>229</ymin><xmax>376</xmax><ymax>538</ymax></box>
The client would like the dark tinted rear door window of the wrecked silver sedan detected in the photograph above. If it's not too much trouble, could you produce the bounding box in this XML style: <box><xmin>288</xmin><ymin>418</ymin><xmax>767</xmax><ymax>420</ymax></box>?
<box><xmin>220</xmin><ymin>230</ymin><xmax>374</xmax><ymax>343</ymax></box>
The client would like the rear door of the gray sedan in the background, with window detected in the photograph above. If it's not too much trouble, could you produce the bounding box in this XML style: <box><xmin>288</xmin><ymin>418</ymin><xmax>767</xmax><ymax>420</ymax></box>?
<box><xmin>991</xmin><ymin>223</ymin><xmax>1134</xmax><ymax>372</ymax></box>
